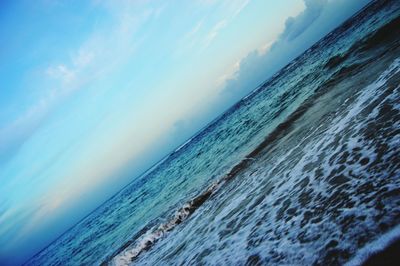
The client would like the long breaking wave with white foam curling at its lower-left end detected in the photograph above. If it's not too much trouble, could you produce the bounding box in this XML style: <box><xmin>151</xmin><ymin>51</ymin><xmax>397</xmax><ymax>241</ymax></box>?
<box><xmin>102</xmin><ymin>55</ymin><xmax>400</xmax><ymax>265</ymax></box>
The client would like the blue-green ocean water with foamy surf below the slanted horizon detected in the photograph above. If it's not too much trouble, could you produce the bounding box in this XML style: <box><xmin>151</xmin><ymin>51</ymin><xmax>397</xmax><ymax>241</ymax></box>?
<box><xmin>26</xmin><ymin>0</ymin><xmax>400</xmax><ymax>265</ymax></box>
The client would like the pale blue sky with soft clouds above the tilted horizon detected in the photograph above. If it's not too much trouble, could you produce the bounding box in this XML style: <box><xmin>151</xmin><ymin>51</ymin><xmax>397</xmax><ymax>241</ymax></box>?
<box><xmin>0</xmin><ymin>0</ymin><xmax>368</xmax><ymax>265</ymax></box>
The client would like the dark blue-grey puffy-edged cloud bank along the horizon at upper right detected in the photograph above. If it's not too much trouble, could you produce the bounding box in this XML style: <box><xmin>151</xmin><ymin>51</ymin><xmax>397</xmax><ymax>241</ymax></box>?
<box><xmin>220</xmin><ymin>0</ymin><xmax>369</xmax><ymax>106</ymax></box>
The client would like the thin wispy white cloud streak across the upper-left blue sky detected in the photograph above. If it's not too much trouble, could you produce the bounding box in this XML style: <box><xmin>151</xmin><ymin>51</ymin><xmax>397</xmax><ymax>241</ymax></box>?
<box><xmin>0</xmin><ymin>2</ymin><xmax>162</xmax><ymax>165</ymax></box>
